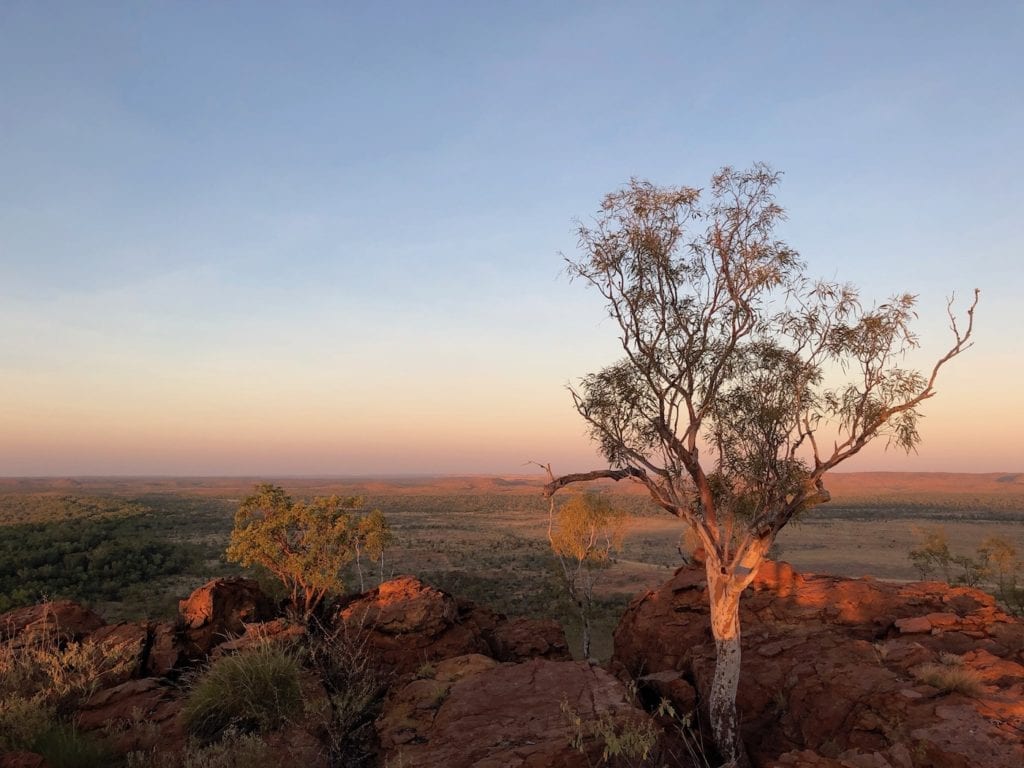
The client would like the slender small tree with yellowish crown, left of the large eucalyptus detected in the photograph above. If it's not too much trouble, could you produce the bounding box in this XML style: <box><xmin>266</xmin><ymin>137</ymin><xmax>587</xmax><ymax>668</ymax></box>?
<box><xmin>548</xmin><ymin>469</ymin><xmax>627</xmax><ymax>658</ymax></box>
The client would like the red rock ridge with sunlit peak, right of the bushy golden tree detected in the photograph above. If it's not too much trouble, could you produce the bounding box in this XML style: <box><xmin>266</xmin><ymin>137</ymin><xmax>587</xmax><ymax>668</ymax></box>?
<box><xmin>333</xmin><ymin>577</ymin><xmax>569</xmax><ymax>676</ymax></box>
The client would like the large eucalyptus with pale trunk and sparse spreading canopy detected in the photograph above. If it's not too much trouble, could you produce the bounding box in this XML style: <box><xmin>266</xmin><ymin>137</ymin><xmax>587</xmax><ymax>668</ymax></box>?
<box><xmin>546</xmin><ymin>165</ymin><xmax>977</xmax><ymax>765</ymax></box>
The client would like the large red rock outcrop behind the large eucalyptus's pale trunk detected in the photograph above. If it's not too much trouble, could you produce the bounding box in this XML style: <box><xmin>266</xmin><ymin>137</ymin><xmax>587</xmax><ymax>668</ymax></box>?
<box><xmin>614</xmin><ymin>563</ymin><xmax>1024</xmax><ymax>768</ymax></box>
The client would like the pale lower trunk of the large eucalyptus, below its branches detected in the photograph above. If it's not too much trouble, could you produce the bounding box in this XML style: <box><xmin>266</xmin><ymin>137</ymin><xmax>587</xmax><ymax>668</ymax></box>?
<box><xmin>706</xmin><ymin>557</ymin><xmax>745</xmax><ymax>768</ymax></box>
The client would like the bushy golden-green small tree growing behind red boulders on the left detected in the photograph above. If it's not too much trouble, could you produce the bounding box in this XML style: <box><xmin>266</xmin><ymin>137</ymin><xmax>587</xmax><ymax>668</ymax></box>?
<box><xmin>227</xmin><ymin>483</ymin><xmax>362</xmax><ymax>618</ymax></box>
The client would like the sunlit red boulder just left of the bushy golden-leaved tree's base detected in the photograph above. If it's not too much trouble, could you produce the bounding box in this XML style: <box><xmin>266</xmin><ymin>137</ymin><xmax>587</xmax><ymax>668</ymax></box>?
<box><xmin>178</xmin><ymin>578</ymin><xmax>274</xmax><ymax>657</ymax></box>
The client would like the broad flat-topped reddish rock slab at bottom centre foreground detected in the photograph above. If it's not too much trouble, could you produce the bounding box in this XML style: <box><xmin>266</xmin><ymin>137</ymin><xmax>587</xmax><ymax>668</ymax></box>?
<box><xmin>377</xmin><ymin>654</ymin><xmax>658</xmax><ymax>768</ymax></box>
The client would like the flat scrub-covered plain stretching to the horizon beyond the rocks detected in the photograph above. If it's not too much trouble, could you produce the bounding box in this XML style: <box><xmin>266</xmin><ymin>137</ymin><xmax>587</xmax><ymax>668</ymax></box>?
<box><xmin>0</xmin><ymin>473</ymin><xmax>1024</xmax><ymax>657</ymax></box>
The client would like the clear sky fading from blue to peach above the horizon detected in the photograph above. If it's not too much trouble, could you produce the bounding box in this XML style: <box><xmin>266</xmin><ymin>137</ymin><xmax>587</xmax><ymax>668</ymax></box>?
<box><xmin>0</xmin><ymin>0</ymin><xmax>1024</xmax><ymax>476</ymax></box>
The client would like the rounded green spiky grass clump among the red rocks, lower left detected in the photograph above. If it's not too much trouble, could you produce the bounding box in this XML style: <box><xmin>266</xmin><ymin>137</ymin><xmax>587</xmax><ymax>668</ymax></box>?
<box><xmin>182</xmin><ymin>644</ymin><xmax>302</xmax><ymax>738</ymax></box>
